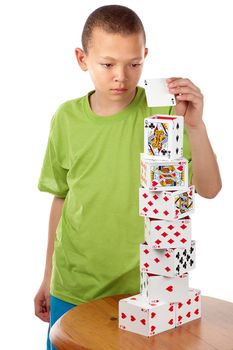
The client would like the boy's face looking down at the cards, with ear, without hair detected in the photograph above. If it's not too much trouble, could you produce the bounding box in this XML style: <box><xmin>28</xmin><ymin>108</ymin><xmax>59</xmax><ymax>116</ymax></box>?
<box><xmin>75</xmin><ymin>28</ymin><xmax>147</xmax><ymax>101</ymax></box>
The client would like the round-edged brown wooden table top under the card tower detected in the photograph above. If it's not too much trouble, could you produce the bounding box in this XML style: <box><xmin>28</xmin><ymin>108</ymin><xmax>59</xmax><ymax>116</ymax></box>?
<box><xmin>50</xmin><ymin>295</ymin><xmax>233</xmax><ymax>350</ymax></box>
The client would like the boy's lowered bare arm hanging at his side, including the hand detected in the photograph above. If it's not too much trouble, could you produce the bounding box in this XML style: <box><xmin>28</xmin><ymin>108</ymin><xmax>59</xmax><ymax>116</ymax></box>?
<box><xmin>34</xmin><ymin>197</ymin><xmax>64</xmax><ymax>322</ymax></box>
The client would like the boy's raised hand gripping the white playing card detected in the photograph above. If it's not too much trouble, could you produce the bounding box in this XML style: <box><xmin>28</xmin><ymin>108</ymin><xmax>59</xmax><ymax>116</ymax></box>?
<box><xmin>167</xmin><ymin>77</ymin><xmax>203</xmax><ymax>128</ymax></box>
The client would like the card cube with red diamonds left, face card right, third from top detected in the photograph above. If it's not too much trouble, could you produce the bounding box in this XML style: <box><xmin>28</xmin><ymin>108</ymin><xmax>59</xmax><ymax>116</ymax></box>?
<box><xmin>139</xmin><ymin>185</ymin><xmax>195</xmax><ymax>220</ymax></box>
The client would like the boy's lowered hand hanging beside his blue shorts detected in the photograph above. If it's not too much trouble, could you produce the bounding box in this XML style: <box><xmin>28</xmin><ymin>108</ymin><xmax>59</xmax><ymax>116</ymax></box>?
<box><xmin>34</xmin><ymin>281</ymin><xmax>50</xmax><ymax>322</ymax></box>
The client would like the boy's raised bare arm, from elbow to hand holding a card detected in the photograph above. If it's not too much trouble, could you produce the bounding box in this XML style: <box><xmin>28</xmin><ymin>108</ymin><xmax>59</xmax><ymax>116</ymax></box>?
<box><xmin>167</xmin><ymin>78</ymin><xmax>222</xmax><ymax>198</ymax></box>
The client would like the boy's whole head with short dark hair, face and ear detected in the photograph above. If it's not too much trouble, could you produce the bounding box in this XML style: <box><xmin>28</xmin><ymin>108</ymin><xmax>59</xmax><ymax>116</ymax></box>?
<box><xmin>75</xmin><ymin>5</ymin><xmax>147</xmax><ymax>105</ymax></box>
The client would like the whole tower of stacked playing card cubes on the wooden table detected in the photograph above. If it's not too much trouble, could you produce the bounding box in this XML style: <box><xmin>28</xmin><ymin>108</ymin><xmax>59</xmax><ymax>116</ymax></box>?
<box><xmin>119</xmin><ymin>115</ymin><xmax>201</xmax><ymax>336</ymax></box>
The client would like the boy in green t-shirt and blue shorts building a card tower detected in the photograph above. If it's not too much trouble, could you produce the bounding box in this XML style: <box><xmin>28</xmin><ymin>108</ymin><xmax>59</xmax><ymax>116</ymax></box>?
<box><xmin>35</xmin><ymin>5</ymin><xmax>221</xmax><ymax>348</ymax></box>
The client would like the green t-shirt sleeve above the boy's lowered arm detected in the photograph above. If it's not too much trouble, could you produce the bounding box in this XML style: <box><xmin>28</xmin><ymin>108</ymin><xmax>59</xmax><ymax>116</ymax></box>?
<box><xmin>38</xmin><ymin>117</ymin><xmax>69</xmax><ymax>198</ymax></box>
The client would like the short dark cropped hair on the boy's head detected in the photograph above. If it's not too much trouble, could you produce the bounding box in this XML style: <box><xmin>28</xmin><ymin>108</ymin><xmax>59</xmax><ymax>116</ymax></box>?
<box><xmin>82</xmin><ymin>5</ymin><xmax>146</xmax><ymax>53</ymax></box>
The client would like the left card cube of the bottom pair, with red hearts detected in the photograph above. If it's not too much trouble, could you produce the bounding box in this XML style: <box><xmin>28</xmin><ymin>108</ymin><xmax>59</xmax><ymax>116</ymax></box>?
<box><xmin>119</xmin><ymin>294</ymin><xmax>175</xmax><ymax>336</ymax></box>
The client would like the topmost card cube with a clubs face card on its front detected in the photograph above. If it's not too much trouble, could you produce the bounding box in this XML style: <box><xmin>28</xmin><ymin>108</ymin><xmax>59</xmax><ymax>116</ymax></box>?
<box><xmin>144</xmin><ymin>114</ymin><xmax>184</xmax><ymax>160</ymax></box>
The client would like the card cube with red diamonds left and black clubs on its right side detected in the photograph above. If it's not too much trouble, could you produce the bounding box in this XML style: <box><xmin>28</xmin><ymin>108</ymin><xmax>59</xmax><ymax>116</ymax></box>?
<box><xmin>140</xmin><ymin>241</ymin><xmax>196</xmax><ymax>277</ymax></box>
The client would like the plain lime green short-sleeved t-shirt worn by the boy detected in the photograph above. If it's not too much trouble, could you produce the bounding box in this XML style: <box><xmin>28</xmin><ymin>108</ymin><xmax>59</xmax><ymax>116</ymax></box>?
<box><xmin>38</xmin><ymin>87</ymin><xmax>191</xmax><ymax>305</ymax></box>
